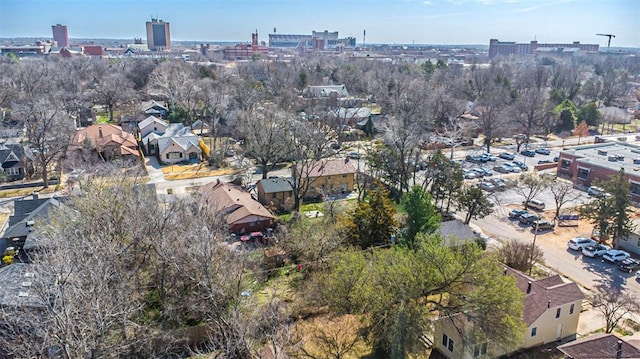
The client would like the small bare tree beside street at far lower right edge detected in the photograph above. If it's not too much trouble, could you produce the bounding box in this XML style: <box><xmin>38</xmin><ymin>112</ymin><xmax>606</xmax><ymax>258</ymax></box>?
<box><xmin>590</xmin><ymin>288</ymin><xmax>640</xmax><ymax>333</ymax></box>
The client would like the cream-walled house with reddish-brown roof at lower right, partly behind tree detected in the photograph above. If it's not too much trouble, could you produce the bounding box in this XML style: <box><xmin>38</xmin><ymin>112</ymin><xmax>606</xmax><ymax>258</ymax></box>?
<box><xmin>433</xmin><ymin>267</ymin><xmax>584</xmax><ymax>359</ymax></box>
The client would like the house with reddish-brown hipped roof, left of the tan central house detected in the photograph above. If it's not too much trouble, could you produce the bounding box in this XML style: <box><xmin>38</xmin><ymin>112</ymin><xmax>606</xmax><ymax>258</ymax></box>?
<box><xmin>200</xmin><ymin>180</ymin><xmax>275</xmax><ymax>233</ymax></box>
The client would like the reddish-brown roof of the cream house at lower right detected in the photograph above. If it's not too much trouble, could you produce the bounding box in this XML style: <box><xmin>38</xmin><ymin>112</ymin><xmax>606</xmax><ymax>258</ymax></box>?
<box><xmin>505</xmin><ymin>267</ymin><xmax>584</xmax><ymax>326</ymax></box>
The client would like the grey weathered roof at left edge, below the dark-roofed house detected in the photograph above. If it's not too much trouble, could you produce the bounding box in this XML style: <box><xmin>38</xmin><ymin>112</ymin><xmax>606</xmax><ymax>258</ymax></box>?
<box><xmin>0</xmin><ymin>263</ymin><xmax>43</xmax><ymax>307</ymax></box>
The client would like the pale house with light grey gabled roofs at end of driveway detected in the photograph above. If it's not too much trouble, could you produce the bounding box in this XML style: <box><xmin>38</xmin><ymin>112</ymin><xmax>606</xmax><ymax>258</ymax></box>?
<box><xmin>138</xmin><ymin>116</ymin><xmax>202</xmax><ymax>164</ymax></box>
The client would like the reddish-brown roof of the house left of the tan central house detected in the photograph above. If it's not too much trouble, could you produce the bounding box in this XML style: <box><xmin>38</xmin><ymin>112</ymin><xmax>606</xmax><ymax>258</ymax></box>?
<box><xmin>200</xmin><ymin>180</ymin><xmax>275</xmax><ymax>224</ymax></box>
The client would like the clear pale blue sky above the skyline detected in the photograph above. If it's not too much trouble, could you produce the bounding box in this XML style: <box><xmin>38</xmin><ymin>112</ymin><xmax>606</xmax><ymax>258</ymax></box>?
<box><xmin>0</xmin><ymin>0</ymin><xmax>640</xmax><ymax>48</ymax></box>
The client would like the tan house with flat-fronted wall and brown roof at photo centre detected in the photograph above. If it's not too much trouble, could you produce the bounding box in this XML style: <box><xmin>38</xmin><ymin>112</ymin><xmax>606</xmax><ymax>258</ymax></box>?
<box><xmin>291</xmin><ymin>158</ymin><xmax>356</xmax><ymax>198</ymax></box>
